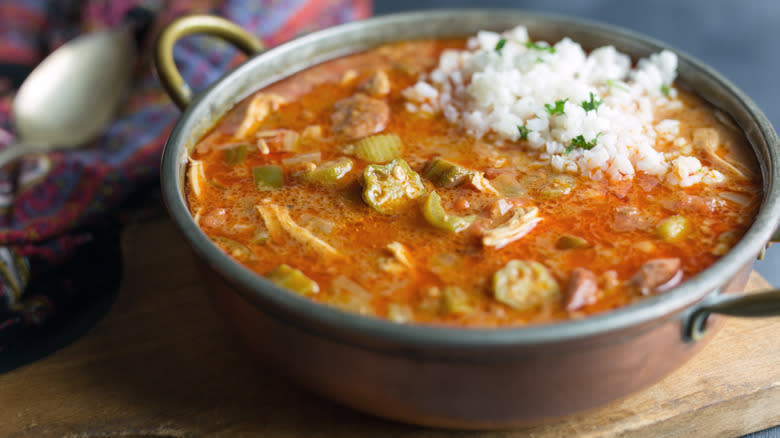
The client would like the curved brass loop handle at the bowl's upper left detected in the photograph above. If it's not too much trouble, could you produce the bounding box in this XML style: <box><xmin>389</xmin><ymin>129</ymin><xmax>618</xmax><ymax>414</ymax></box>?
<box><xmin>154</xmin><ymin>15</ymin><xmax>265</xmax><ymax>110</ymax></box>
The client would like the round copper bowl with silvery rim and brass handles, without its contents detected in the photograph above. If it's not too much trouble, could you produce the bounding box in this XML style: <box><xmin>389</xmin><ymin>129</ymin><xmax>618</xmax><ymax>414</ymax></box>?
<box><xmin>156</xmin><ymin>10</ymin><xmax>780</xmax><ymax>428</ymax></box>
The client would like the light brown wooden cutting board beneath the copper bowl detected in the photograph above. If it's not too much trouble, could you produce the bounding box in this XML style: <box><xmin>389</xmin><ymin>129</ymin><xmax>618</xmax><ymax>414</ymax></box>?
<box><xmin>0</xmin><ymin>220</ymin><xmax>780</xmax><ymax>438</ymax></box>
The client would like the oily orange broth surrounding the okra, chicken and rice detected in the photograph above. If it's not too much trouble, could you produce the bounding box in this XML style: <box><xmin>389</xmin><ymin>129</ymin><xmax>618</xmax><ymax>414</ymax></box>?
<box><xmin>186</xmin><ymin>40</ymin><xmax>761</xmax><ymax>327</ymax></box>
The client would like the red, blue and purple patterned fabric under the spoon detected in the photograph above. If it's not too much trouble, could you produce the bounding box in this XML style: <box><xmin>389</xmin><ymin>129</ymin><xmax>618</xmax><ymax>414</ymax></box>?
<box><xmin>0</xmin><ymin>0</ymin><xmax>371</xmax><ymax>354</ymax></box>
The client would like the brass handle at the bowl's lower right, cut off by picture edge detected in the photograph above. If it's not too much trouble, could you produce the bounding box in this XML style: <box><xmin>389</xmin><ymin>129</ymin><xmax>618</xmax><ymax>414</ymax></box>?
<box><xmin>684</xmin><ymin>289</ymin><xmax>780</xmax><ymax>341</ymax></box>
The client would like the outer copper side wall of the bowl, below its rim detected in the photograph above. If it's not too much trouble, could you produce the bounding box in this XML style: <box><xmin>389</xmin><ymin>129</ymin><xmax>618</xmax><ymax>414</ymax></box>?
<box><xmin>202</xmin><ymin>260</ymin><xmax>750</xmax><ymax>429</ymax></box>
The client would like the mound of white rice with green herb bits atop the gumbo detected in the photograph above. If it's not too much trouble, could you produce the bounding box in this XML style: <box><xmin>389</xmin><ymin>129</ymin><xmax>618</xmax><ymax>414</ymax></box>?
<box><xmin>403</xmin><ymin>26</ymin><xmax>723</xmax><ymax>187</ymax></box>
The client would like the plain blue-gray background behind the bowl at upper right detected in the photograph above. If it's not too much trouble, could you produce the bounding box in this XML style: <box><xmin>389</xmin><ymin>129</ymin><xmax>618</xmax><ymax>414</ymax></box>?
<box><xmin>374</xmin><ymin>0</ymin><xmax>780</xmax><ymax>288</ymax></box>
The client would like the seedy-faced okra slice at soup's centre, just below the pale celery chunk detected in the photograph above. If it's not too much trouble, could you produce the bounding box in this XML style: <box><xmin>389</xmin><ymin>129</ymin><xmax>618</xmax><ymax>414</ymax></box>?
<box><xmin>363</xmin><ymin>158</ymin><xmax>425</xmax><ymax>214</ymax></box>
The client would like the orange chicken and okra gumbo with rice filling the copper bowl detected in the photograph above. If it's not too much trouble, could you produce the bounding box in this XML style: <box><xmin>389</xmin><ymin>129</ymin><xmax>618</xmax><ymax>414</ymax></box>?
<box><xmin>185</xmin><ymin>27</ymin><xmax>761</xmax><ymax>327</ymax></box>
